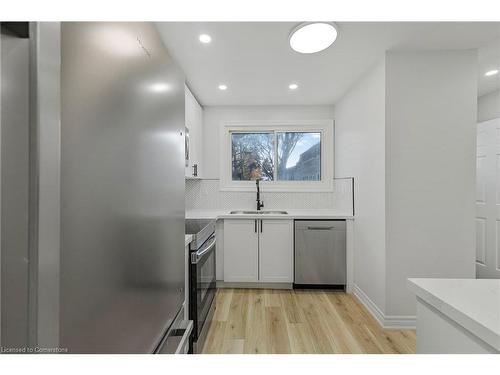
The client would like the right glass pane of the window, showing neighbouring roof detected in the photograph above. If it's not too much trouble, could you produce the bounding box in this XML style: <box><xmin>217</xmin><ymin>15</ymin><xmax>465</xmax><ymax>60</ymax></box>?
<box><xmin>277</xmin><ymin>132</ymin><xmax>321</xmax><ymax>181</ymax></box>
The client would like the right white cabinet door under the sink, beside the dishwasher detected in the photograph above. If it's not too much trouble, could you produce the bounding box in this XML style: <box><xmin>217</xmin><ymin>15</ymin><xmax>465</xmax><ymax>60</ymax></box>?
<box><xmin>258</xmin><ymin>220</ymin><xmax>293</xmax><ymax>283</ymax></box>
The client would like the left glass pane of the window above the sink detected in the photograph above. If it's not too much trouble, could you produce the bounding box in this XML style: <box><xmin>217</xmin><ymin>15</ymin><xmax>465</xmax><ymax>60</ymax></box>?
<box><xmin>231</xmin><ymin>132</ymin><xmax>274</xmax><ymax>181</ymax></box>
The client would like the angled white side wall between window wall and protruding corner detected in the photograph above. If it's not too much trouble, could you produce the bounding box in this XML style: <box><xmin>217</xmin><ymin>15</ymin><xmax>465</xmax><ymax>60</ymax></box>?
<box><xmin>335</xmin><ymin>61</ymin><xmax>385</xmax><ymax>311</ymax></box>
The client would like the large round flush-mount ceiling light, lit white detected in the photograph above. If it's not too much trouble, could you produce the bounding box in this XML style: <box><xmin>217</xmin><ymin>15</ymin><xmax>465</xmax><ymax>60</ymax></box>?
<box><xmin>289</xmin><ymin>22</ymin><xmax>338</xmax><ymax>53</ymax></box>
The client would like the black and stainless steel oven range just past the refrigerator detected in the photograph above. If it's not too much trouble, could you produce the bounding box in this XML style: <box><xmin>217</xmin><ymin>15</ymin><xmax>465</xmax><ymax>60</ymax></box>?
<box><xmin>186</xmin><ymin>219</ymin><xmax>216</xmax><ymax>353</ymax></box>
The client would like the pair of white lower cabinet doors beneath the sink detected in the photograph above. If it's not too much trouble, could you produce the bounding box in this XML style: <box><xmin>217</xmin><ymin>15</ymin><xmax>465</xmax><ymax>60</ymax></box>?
<box><xmin>224</xmin><ymin>219</ymin><xmax>293</xmax><ymax>283</ymax></box>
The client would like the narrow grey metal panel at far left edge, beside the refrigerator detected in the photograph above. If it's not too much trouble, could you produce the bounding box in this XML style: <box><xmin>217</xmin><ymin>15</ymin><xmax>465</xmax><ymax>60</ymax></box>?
<box><xmin>0</xmin><ymin>22</ymin><xmax>30</xmax><ymax>348</ymax></box>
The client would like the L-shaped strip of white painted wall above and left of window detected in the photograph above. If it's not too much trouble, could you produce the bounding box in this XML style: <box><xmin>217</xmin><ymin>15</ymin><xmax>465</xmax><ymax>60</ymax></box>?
<box><xmin>202</xmin><ymin>106</ymin><xmax>334</xmax><ymax>179</ymax></box>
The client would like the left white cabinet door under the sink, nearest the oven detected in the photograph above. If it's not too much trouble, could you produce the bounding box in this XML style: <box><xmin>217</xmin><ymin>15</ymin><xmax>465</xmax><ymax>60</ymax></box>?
<box><xmin>224</xmin><ymin>219</ymin><xmax>259</xmax><ymax>282</ymax></box>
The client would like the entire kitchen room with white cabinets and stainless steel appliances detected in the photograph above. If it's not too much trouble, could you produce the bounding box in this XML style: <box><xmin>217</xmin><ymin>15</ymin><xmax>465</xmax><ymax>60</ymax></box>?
<box><xmin>0</xmin><ymin>0</ymin><xmax>500</xmax><ymax>372</ymax></box>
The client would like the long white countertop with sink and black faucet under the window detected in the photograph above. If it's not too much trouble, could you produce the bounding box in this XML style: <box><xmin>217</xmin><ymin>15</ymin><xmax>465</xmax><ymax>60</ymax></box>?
<box><xmin>186</xmin><ymin>208</ymin><xmax>354</xmax><ymax>220</ymax></box>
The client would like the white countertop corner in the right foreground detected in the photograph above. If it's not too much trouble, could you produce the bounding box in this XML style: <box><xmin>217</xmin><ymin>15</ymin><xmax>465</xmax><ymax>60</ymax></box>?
<box><xmin>408</xmin><ymin>279</ymin><xmax>500</xmax><ymax>351</ymax></box>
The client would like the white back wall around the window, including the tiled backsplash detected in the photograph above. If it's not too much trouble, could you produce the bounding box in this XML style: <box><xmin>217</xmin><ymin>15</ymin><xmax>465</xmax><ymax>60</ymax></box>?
<box><xmin>190</xmin><ymin>106</ymin><xmax>360</xmax><ymax>213</ymax></box>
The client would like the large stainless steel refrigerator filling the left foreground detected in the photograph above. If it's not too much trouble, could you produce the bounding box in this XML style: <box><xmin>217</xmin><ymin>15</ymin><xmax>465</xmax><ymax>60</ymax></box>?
<box><xmin>2</xmin><ymin>22</ymin><xmax>185</xmax><ymax>353</ymax></box>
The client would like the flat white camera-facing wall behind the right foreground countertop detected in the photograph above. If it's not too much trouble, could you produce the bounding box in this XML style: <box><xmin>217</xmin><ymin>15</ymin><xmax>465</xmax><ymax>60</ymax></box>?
<box><xmin>385</xmin><ymin>50</ymin><xmax>477</xmax><ymax>315</ymax></box>
